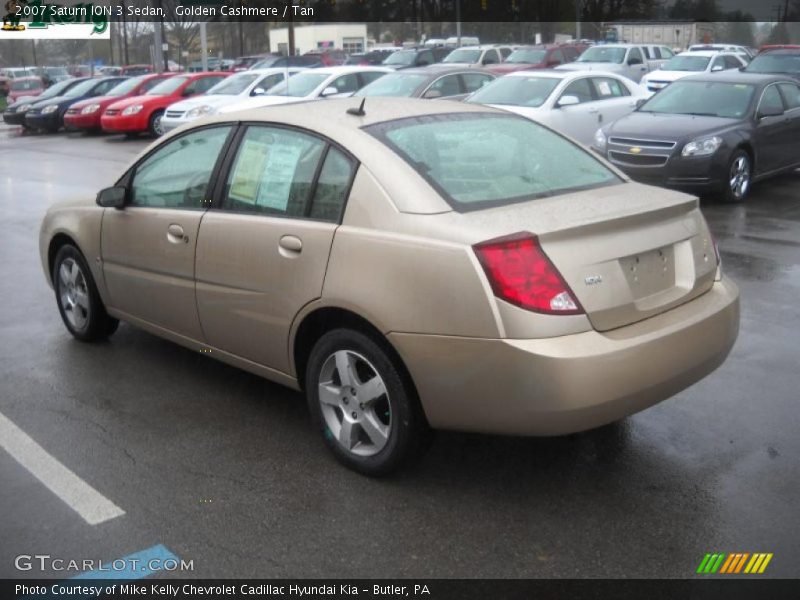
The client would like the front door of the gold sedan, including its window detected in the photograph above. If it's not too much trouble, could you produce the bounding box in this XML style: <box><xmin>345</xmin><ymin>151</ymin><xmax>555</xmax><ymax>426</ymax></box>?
<box><xmin>101</xmin><ymin>125</ymin><xmax>231</xmax><ymax>340</ymax></box>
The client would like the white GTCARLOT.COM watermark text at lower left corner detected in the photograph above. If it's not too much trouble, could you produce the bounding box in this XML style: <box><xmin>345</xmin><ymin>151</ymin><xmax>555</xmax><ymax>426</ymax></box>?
<box><xmin>14</xmin><ymin>554</ymin><xmax>194</xmax><ymax>576</ymax></box>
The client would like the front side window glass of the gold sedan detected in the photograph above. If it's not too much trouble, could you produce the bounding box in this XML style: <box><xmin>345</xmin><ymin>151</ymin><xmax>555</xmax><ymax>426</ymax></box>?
<box><xmin>131</xmin><ymin>125</ymin><xmax>231</xmax><ymax>209</ymax></box>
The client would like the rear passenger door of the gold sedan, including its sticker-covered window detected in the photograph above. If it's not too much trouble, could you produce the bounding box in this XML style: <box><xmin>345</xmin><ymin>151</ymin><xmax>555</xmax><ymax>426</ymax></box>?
<box><xmin>196</xmin><ymin>125</ymin><xmax>356</xmax><ymax>373</ymax></box>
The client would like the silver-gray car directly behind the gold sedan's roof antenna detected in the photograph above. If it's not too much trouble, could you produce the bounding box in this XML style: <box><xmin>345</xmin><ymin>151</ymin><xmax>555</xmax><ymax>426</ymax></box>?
<box><xmin>354</xmin><ymin>67</ymin><xmax>497</xmax><ymax>100</ymax></box>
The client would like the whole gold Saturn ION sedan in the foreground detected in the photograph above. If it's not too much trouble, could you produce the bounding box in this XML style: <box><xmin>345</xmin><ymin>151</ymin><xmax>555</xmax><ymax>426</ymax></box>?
<box><xmin>40</xmin><ymin>98</ymin><xmax>739</xmax><ymax>475</ymax></box>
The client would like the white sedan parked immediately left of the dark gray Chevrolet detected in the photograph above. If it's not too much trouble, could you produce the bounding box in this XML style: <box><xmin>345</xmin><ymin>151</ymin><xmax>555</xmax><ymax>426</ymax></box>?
<box><xmin>466</xmin><ymin>70</ymin><xmax>647</xmax><ymax>146</ymax></box>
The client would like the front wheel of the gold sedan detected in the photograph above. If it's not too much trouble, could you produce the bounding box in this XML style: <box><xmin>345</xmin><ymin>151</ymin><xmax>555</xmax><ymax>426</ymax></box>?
<box><xmin>52</xmin><ymin>244</ymin><xmax>119</xmax><ymax>342</ymax></box>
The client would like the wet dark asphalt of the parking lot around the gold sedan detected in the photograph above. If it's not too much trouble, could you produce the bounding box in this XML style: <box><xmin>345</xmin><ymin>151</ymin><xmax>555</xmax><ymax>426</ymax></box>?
<box><xmin>0</xmin><ymin>127</ymin><xmax>800</xmax><ymax>578</ymax></box>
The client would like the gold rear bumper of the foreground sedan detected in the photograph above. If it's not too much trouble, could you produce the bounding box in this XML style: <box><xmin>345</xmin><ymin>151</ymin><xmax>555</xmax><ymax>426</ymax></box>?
<box><xmin>389</xmin><ymin>279</ymin><xmax>739</xmax><ymax>436</ymax></box>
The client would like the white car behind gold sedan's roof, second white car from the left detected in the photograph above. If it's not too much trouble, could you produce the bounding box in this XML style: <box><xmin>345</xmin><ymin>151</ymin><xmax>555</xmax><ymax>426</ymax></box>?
<box><xmin>219</xmin><ymin>65</ymin><xmax>394</xmax><ymax>113</ymax></box>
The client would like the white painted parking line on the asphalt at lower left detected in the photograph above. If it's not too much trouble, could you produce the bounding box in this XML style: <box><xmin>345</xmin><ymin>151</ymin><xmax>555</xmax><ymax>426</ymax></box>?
<box><xmin>0</xmin><ymin>413</ymin><xmax>125</xmax><ymax>525</ymax></box>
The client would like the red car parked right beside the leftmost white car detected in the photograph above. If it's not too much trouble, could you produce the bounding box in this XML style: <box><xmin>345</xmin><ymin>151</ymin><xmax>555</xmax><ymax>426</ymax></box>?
<box><xmin>100</xmin><ymin>71</ymin><xmax>230</xmax><ymax>137</ymax></box>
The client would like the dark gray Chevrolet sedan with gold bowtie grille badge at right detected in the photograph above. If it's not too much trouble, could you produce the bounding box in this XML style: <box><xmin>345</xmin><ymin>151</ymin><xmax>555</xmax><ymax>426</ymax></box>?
<box><xmin>594</xmin><ymin>71</ymin><xmax>800</xmax><ymax>202</ymax></box>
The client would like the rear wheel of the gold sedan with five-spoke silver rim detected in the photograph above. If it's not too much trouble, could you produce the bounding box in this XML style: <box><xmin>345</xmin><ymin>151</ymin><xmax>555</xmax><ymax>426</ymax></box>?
<box><xmin>305</xmin><ymin>329</ymin><xmax>430</xmax><ymax>477</ymax></box>
